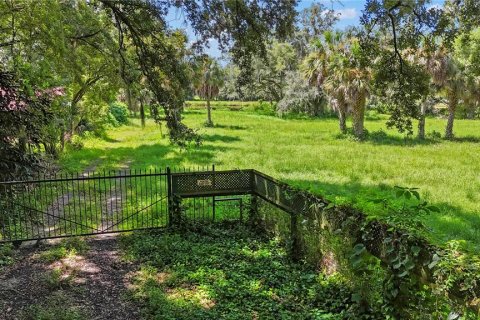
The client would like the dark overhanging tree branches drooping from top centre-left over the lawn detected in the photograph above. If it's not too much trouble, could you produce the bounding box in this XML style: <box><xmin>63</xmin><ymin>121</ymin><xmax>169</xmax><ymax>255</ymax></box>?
<box><xmin>99</xmin><ymin>0</ymin><xmax>295</xmax><ymax>145</ymax></box>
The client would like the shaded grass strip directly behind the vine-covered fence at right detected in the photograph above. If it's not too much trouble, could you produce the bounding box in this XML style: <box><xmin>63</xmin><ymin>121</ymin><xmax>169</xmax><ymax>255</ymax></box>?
<box><xmin>285</xmin><ymin>179</ymin><xmax>480</xmax><ymax>253</ymax></box>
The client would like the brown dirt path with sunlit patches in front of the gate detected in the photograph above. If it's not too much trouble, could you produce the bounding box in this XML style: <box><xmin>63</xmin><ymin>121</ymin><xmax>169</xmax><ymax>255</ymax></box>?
<box><xmin>0</xmin><ymin>236</ymin><xmax>140</xmax><ymax>320</ymax></box>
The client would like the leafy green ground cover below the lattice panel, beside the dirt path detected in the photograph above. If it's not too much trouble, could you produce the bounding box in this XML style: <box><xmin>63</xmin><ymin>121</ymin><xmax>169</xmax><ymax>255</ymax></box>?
<box><xmin>118</xmin><ymin>224</ymin><xmax>379</xmax><ymax>319</ymax></box>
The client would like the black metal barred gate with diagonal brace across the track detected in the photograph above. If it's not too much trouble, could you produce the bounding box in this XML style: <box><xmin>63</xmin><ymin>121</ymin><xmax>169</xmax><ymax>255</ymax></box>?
<box><xmin>0</xmin><ymin>170</ymin><xmax>169</xmax><ymax>241</ymax></box>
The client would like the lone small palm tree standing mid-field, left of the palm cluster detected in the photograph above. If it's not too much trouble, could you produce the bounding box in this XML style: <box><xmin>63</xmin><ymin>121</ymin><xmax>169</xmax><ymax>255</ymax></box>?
<box><xmin>196</xmin><ymin>57</ymin><xmax>224</xmax><ymax>127</ymax></box>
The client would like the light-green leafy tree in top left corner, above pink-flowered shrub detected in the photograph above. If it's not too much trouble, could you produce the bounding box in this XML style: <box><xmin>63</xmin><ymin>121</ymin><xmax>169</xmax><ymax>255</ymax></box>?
<box><xmin>0</xmin><ymin>0</ymin><xmax>118</xmax><ymax>152</ymax></box>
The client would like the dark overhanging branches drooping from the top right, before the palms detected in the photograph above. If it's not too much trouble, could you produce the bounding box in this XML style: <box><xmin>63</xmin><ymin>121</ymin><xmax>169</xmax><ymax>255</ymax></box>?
<box><xmin>359</xmin><ymin>0</ymin><xmax>480</xmax><ymax>138</ymax></box>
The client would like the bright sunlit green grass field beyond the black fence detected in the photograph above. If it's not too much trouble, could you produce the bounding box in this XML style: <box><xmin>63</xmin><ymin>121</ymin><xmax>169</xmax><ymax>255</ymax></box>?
<box><xmin>61</xmin><ymin>108</ymin><xmax>480</xmax><ymax>252</ymax></box>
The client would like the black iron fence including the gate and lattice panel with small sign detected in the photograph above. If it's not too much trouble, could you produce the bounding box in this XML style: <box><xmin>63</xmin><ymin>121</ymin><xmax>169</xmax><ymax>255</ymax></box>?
<box><xmin>0</xmin><ymin>167</ymin><xmax>318</xmax><ymax>242</ymax></box>
